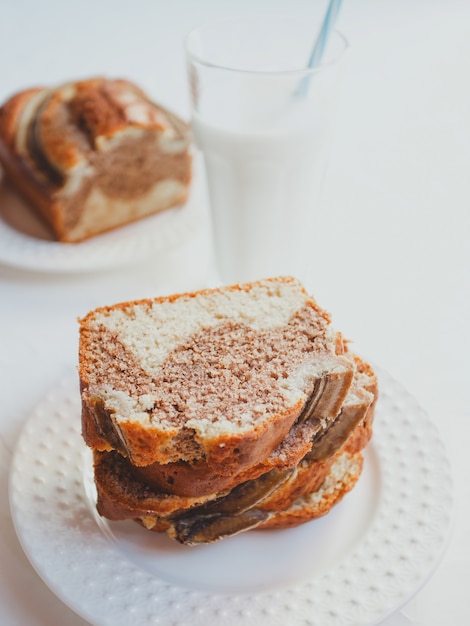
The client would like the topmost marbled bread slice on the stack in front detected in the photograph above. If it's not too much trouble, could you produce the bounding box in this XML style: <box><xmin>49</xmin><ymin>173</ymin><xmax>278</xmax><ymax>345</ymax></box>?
<box><xmin>79</xmin><ymin>278</ymin><xmax>354</xmax><ymax>465</ymax></box>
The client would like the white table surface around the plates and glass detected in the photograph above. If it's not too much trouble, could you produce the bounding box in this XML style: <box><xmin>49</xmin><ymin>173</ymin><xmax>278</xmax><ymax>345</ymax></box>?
<box><xmin>0</xmin><ymin>0</ymin><xmax>470</xmax><ymax>626</ymax></box>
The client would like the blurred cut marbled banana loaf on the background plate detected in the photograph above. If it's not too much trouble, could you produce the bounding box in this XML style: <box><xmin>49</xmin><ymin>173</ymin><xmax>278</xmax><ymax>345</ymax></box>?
<box><xmin>0</xmin><ymin>78</ymin><xmax>191</xmax><ymax>242</ymax></box>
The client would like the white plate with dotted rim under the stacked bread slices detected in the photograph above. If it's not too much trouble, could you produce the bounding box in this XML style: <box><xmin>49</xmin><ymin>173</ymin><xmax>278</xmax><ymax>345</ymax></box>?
<box><xmin>10</xmin><ymin>370</ymin><xmax>452</xmax><ymax>626</ymax></box>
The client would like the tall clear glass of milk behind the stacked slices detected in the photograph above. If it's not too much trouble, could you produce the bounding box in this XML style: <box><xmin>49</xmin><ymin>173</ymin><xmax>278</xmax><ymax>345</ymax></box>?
<box><xmin>186</xmin><ymin>16</ymin><xmax>348</xmax><ymax>283</ymax></box>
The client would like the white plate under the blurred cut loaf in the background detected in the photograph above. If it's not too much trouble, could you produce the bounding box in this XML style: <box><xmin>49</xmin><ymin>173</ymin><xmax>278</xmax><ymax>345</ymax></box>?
<box><xmin>0</xmin><ymin>162</ymin><xmax>202</xmax><ymax>272</ymax></box>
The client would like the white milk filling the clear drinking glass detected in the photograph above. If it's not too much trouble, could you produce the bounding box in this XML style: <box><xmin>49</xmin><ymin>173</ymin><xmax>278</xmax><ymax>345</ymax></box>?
<box><xmin>193</xmin><ymin>92</ymin><xmax>328</xmax><ymax>282</ymax></box>
